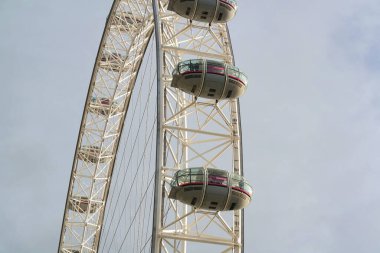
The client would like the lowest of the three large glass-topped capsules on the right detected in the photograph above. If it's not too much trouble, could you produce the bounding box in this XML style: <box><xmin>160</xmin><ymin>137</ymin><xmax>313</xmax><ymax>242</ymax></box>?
<box><xmin>169</xmin><ymin>168</ymin><xmax>253</xmax><ymax>211</ymax></box>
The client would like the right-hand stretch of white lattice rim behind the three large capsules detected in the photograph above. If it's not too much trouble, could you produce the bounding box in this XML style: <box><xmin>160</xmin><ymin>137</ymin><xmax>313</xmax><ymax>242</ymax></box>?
<box><xmin>152</xmin><ymin>1</ymin><xmax>243</xmax><ymax>253</ymax></box>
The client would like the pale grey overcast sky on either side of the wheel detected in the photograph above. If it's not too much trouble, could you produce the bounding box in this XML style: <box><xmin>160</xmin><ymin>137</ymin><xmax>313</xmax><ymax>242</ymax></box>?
<box><xmin>0</xmin><ymin>0</ymin><xmax>380</xmax><ymax>253</ymax></box>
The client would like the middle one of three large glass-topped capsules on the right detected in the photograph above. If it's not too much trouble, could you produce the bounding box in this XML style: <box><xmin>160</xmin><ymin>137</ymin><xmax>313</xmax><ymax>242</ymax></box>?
<box><xmin>171</xmin><ymin>59</ymin><xmax>248</xmax><ymax>100</ymax></box>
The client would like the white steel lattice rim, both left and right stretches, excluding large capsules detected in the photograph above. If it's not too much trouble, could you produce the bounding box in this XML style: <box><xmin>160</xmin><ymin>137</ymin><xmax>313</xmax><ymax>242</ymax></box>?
<box><xmin>58</xmin><ymin>0</ymin><xmax>243</xmax><ymax>253</ymax></box>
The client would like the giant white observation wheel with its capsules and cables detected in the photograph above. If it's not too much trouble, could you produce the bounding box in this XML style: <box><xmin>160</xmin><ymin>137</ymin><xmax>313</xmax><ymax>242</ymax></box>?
<box><xmin>58</xmin><ymin>0</ymin><xmax>253</xmax><ymax>253</ymax></box>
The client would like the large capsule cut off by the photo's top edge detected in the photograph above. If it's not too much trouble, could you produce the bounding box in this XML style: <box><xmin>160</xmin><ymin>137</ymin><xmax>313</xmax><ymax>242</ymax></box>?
<box><xmin>168</xmin><ymin>0</ymin><xmax>237</xmax><ymax>23</ymax></box>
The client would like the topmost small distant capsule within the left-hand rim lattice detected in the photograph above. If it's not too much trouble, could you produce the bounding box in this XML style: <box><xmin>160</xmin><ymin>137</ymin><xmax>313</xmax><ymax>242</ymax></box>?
<box><xmin>111</xmin><ymin>12</ymin><xmax>144</xmax><ymax>32</ymax></box>
